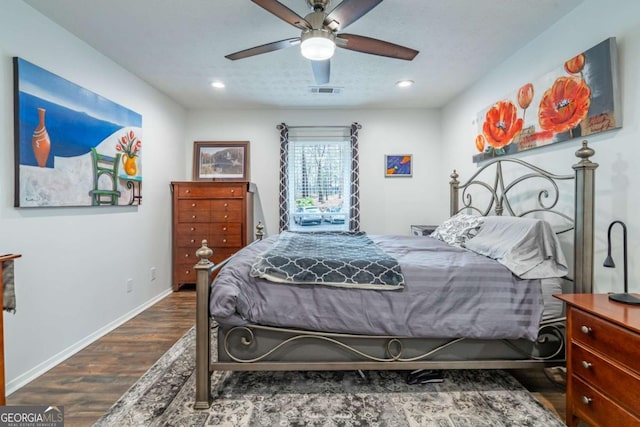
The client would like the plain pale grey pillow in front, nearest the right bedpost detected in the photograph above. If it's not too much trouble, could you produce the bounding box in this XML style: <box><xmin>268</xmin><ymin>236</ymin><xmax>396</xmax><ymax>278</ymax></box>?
<box><xmin>465</xmin><ymin>216</ymin><xmax>568</xmax><ymax>279</ymax></box>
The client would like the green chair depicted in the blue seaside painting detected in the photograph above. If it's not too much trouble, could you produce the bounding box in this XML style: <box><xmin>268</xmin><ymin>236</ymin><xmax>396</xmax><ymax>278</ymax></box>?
<box><xmin>89</xmin><ymin>147</ymin><xmax>120</xmax><ymax>206</ymax></box>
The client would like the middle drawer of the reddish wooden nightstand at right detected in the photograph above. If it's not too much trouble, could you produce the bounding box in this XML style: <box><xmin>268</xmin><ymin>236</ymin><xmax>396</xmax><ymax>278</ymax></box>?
<box><xmin>571</xmin><ymin>343</ymin><xmax>640</xmax><ymax>416</ymax></box>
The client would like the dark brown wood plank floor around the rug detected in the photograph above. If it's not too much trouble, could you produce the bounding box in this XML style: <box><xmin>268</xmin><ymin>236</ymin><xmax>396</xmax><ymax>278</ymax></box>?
<box><xmin>7</xmin><ymin>288</ymin><xmax>565</xmax><ymax>427</ymax></box>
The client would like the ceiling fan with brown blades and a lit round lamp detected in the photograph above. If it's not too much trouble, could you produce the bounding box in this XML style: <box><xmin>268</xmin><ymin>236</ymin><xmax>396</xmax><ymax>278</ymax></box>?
<box><xmin>225</xmin><ymin>0</ymin><xmax>418</xmax><ymax>84</ymax></box>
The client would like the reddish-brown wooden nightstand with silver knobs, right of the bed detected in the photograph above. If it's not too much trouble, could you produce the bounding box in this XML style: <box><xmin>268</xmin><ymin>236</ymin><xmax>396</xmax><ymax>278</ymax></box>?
<box><xmin>555</xmin><ymin>294</ymin><xmax>640</xmax><ymax>427</ymax></box>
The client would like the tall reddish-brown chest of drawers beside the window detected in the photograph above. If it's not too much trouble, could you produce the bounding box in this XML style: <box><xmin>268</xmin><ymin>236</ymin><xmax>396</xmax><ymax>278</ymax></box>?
<box><xmin>171</xmin><ymin>181</ymin><xmax>253</xmax><ymax>291</ymax></box>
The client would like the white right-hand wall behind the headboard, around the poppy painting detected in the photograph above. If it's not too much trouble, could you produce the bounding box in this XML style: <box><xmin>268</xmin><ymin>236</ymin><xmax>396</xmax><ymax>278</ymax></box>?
<box><xmin>442</xmin><ymin>0</ymin><xmax>640</xmax><ymax>292</ymax></box>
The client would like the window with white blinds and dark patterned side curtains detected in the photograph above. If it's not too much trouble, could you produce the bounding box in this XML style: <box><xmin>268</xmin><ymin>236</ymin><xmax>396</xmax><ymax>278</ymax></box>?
<box><xmin>280</xmin><ymin>124</ymin><xmax>359</xmax><ymax>231</ymax></box>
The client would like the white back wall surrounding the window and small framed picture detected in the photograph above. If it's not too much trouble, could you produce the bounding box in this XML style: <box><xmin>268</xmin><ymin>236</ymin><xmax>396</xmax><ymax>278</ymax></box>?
<box><xmin>185</xmin><ymin>110</ymin><xmax>440</xmax><ymax>234</ymax></box>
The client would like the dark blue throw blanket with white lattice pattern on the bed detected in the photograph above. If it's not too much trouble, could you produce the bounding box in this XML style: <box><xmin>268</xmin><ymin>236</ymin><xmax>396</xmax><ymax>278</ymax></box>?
<box><xmin>251</xmin><ymin>231</ymin><xmax>404</xmax><ymax>290</ymax></box>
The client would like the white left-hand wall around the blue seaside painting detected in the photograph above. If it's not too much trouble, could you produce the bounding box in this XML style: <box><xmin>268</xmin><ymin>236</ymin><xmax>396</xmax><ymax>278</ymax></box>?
<box><xmin>0</xmin><ymin>1</ymin><xmax>185</xmax><ymax>392</ymax></box>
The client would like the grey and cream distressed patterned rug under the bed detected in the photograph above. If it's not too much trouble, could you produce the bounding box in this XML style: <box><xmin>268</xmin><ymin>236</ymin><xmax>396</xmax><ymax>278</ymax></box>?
<box><xmin>95</xmin><ymin>329</ymin><xmax>564</xmax><ymax>427</ymax></box>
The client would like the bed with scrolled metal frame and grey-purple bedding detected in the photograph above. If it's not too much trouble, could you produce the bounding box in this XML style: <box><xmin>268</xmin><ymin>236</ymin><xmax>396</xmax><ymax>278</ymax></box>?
<box><xmin>195</xmin><ymin>141</ymin><xmax>598</xmax><ymax>409</ymax></box>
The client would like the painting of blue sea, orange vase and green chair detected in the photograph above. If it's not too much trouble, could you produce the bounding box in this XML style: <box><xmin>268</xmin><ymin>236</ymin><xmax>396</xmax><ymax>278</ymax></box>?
<box><xmin>14</xmin><ymin>58</ymin><xmax>142</xmax><ymax>207</ymax></box>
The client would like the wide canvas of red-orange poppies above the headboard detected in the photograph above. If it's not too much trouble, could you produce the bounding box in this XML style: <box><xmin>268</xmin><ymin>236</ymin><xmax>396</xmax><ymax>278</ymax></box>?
<box><xmin>472</xmin><ymin>37</ymin><xmax>622</xmax><ymax>163</ymax></box>
